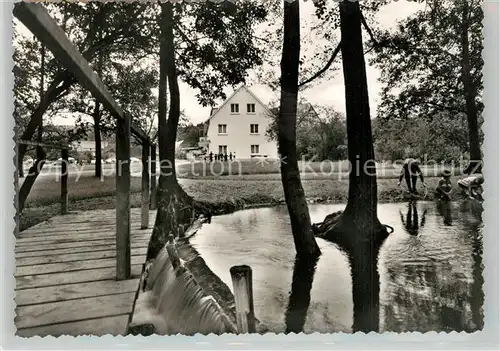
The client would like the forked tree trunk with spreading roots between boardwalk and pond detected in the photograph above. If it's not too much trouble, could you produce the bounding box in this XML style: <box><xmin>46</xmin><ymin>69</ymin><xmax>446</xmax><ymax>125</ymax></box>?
<box><xmin>146</xmin><ymin>2</ymin><xmax>193</xmax><ymax>260</ymax></box>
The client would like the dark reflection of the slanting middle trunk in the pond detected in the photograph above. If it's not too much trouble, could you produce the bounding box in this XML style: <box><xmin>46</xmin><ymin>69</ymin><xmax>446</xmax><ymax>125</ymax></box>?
<box><xmin>285</xmin><ymin>256</ymin><xmax>319</xmax><ymax>333</ymax></box>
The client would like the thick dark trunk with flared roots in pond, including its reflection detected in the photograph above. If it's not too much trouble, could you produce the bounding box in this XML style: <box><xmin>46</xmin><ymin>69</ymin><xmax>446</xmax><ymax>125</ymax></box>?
<box><xmin>325</xmin><ymin>0</ymin><xmax>387</xmax><ymax>332</ymax></box>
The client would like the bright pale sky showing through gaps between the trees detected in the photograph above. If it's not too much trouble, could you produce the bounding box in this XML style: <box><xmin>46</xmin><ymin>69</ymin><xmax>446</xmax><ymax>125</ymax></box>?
<box><xmin>25</xmin><ymin>1</ymin><xmax>425</xmax><ymax>125</ymax></box>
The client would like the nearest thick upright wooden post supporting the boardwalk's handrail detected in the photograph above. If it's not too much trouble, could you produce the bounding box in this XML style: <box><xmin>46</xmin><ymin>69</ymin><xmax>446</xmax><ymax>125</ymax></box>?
<box><xmin>116</xmin><ymin>116</ymin><xmax>131</xmax><ymax>280</ymax></box>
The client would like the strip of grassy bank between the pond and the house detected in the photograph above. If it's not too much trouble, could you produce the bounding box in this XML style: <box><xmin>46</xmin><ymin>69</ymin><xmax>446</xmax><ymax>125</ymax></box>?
<box><xmin>21</xmin><ymin>176</ymin><xmax>459</xmax><ymax>230</ymax></box>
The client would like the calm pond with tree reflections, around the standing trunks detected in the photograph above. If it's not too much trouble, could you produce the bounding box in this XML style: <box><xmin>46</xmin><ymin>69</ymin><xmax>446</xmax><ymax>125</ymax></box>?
<box><xmin>190</xmin><ymin>201</ymin><xmax>483</xmax><ymax>333</ymax></box>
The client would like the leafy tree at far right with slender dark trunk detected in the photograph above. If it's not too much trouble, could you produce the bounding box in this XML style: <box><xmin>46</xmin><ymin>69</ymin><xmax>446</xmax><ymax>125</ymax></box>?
<box><xmin>373</xmin><ymin>0</ymin><xmax>483</xmax><ymax>172</ymax></box>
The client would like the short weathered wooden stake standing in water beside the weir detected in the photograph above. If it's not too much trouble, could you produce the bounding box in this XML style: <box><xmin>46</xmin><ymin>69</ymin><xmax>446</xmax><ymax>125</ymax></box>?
<box><xmin>229</xmin><ymin>265</ymin><xmax>256</xmax><ymax>333</ymax></box>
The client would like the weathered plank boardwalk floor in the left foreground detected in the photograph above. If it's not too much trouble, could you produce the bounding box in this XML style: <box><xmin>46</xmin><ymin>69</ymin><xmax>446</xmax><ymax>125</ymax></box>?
<box><xmin>15</xmin><ymin>209</ymin><xmax>155</xmax><ymax>337</ymax></box>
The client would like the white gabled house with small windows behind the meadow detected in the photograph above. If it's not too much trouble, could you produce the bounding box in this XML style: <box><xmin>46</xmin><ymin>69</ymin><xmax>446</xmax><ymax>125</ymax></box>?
<box><xmin>205</xmin><ymin>85</ymin><xmax>278</xmax><ymax>159</ymax></box>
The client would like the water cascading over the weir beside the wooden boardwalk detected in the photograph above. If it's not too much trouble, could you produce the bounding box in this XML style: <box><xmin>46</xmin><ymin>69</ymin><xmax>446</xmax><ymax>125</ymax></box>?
<box><xmin>129</xmin><ymin>239</ymin><xmax>237</xmax><ymax>335</ymax></box>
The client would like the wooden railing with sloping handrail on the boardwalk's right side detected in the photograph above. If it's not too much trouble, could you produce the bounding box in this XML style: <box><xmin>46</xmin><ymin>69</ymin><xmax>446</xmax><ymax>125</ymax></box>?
<box><xmin>13</xmin><ymin>2</ymin><xmax>156</xmax><ymax>280</ymax></box>
